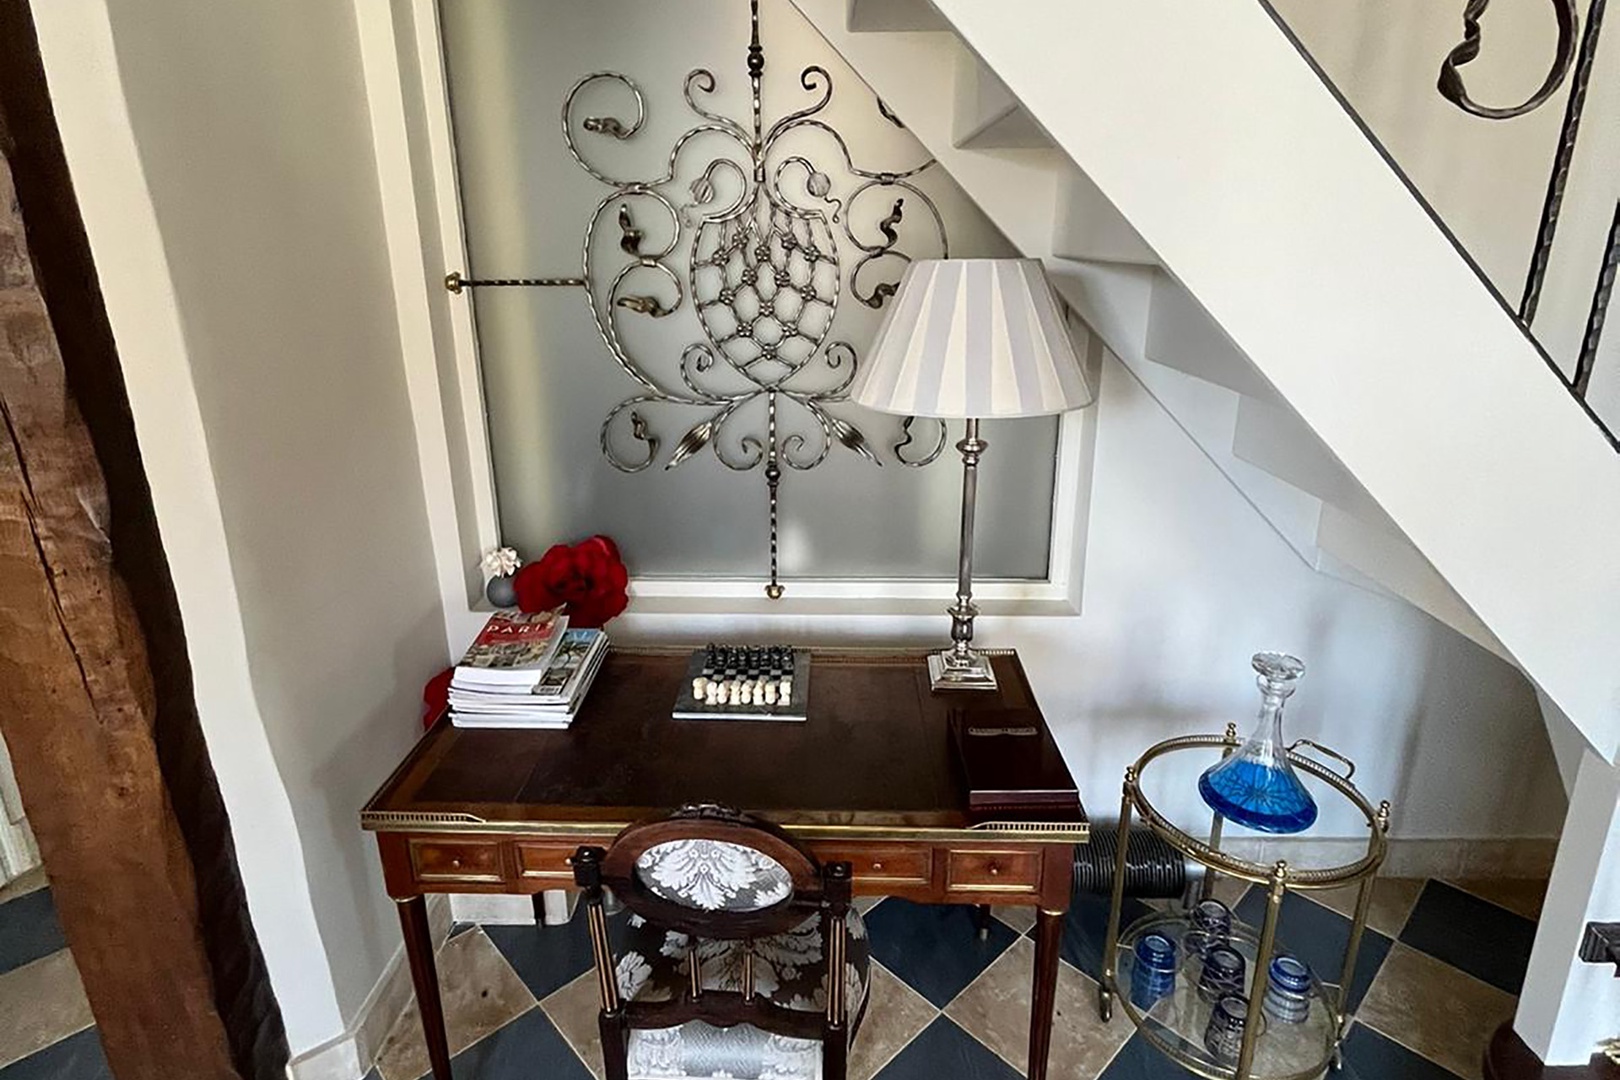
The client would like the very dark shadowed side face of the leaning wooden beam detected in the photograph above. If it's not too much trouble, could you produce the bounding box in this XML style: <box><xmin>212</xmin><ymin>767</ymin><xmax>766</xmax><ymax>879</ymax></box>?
<box><xmin>0</xmin><ymin>2</ymin><xmax>288</xmax><ymax>1080</ymax></box>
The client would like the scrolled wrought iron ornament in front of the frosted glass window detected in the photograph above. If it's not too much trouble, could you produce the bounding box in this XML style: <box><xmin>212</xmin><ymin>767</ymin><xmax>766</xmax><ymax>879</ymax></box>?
<box><xmin>446</xmin><ymin>0</ymin><xmax>949</xmax><ymax>599</ymax></box>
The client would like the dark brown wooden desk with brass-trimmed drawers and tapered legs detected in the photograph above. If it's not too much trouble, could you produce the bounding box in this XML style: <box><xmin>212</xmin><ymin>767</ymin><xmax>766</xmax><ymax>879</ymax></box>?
<box><xmin>361</xmin><ymin>649</ymin><xmax>1087</xmax><ymax>1080</ymax></box>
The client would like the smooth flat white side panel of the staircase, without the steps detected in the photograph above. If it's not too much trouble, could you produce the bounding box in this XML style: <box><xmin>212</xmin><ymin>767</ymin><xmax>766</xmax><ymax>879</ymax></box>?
<box><xmin>933</xmin><ymin>0</ymin><xmax>1620</xmax><ymax>761</ymax></box>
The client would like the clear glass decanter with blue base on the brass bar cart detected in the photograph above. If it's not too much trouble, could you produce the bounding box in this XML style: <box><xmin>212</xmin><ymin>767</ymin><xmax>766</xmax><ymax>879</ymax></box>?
<box><xmin>1199</xmin><ymin>653</ymin><xmax>1317</xmax><ymax>832</ymax></box>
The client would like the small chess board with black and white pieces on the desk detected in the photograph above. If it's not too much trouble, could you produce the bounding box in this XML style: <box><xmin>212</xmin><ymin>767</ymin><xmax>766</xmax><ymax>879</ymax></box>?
<box><xmin>671</xmin><ymin>644</ymin><xmax>810</xmax><ymax>722</ymax></box>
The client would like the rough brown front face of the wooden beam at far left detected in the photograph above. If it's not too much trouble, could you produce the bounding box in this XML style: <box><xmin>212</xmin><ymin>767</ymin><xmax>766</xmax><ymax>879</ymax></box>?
<box><xmin>0</xmin><ymin>127</ymin><xmax>238</xmax><ymax>1080</ymax></box>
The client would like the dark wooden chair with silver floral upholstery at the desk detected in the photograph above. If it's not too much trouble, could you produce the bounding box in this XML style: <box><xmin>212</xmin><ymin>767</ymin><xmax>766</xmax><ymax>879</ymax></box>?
<box><xmin>573</xmin><ymin>806</ymin><xmax>870</xmax><ymax>1080</ymax></box>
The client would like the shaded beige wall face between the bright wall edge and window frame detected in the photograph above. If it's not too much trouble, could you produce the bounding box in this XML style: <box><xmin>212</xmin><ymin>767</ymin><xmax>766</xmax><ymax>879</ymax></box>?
<box><xmin>93</xmin><ymin>0</ymin><xmax>446</xmax><ymax>1036</ymax></box>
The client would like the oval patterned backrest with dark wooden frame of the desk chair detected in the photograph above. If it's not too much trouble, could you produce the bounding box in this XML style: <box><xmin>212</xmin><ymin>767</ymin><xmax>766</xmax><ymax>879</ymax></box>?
<box><xmin>601</xmin><ymin>805</ymin><xmax>823</xmax><ymax>939</ymax></box>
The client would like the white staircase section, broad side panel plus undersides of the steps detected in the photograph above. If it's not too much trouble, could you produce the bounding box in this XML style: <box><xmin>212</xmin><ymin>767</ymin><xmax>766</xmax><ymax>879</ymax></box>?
<box><xmin>792</xmin><ymin>0</ymin><xmax>1620</xmax><ymax>759</ymax></box>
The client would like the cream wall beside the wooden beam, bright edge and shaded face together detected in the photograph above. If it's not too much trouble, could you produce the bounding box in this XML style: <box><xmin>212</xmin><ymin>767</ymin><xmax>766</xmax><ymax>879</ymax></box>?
<box><xmin>36</xmin><ymin>0</ymin><xmax>446</xmax><ymax>1054</ymax></box>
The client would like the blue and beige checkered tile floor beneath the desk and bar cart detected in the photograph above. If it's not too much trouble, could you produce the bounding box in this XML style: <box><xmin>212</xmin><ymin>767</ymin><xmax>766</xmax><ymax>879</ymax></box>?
<box><xmin>367</xmin><ymin>881</ymin><xmax>1544</xmax><ymax>1080</ymax></box>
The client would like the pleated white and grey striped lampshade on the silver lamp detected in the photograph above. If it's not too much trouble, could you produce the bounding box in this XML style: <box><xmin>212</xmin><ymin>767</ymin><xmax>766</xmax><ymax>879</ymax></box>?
<box><xmin>849</xmin><ymin>259</ymin><xmax>1092</xmax><ymax>419</ymax></box>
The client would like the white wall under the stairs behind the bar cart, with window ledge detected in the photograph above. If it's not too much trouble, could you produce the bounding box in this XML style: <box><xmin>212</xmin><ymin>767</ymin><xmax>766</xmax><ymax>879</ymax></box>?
<box><xmin>599</xmin><ymin>358</ymin><xmax>1563</xmax><ymax>839</ymax></box>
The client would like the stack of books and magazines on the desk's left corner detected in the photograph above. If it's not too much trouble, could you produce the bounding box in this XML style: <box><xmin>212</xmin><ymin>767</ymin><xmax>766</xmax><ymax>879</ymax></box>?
<box><xmin>450</xmin><ymin>612</ymin><xmax>608</xmax><ymax>729</ymax></box>
